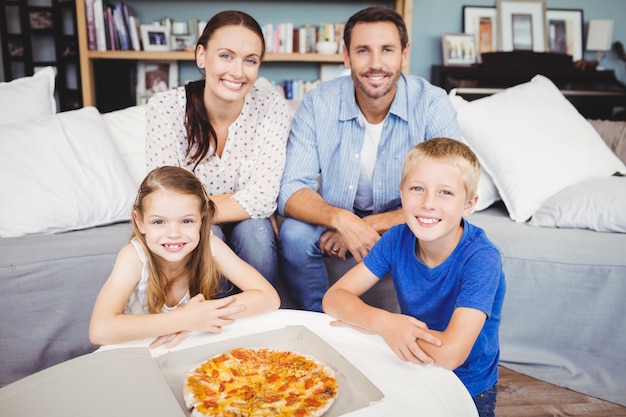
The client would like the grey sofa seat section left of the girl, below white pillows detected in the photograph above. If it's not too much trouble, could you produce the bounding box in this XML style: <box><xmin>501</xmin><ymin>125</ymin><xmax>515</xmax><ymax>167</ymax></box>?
<box><xmin>0</xmin><ymin>222</ymin><xmax>133</xmax><ymax>386</ymax></box>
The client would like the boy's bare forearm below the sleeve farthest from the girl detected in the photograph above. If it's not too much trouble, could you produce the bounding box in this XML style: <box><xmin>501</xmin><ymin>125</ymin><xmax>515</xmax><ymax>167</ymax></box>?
<box><xmin>417</xmin><ymin>307</ymin><xmax>487</xmax><ymax>370</ymax></box>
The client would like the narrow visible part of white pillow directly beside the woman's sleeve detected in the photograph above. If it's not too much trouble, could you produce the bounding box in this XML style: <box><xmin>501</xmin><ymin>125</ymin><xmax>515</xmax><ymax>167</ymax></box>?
<box><xmin>102</xmin><ymin>104</ymin><xmax>148</xmax><ymax>188</ymax></box>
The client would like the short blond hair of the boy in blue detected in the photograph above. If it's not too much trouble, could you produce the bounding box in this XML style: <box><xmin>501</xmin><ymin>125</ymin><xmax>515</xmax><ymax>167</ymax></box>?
<box><xmin>400</xmin><ymin>138</ymin><xmax>480</xmax><ymax>202</ymax></box>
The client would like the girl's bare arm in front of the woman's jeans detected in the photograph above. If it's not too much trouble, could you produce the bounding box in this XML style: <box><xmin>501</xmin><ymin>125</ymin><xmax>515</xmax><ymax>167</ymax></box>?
<box><xmin>211</xmin><ymin>236</ymin><xmax>280</xmax><ymax>319</ymax></box>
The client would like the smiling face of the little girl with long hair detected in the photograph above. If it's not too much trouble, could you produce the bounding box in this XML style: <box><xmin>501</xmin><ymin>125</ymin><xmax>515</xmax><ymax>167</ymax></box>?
<box><xmin>133</xmin><ymin>190</ymin><xmax>202</xmax><ymax>262</ymax></box>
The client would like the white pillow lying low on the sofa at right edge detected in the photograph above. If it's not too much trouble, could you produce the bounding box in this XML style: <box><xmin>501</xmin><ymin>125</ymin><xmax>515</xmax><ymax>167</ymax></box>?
<box><xmin>528</xmin><ymin>177</ymin><xmax>626</xmax><ymax>233</ymax></box>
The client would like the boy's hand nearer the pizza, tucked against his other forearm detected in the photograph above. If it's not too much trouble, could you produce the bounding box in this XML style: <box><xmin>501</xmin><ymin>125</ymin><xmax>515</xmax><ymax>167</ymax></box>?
<box><xmin>380</xmin><ymin>314</ymin><xmax>441</xmax><ymax>364</ymax></box>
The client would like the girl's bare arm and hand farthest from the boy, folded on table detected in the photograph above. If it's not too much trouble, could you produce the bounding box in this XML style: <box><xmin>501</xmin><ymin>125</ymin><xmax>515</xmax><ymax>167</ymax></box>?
<box><xmin>89</xmin><ymin>240</ymin><xmax>245</xmax><ymax>345</ymax></box>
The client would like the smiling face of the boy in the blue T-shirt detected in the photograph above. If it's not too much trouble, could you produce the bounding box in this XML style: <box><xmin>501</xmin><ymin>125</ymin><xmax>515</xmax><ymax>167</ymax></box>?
<box><xmin>400</xmin><ymin>158</ymin><xmax>478</xmax><ymax>245</ymax></box>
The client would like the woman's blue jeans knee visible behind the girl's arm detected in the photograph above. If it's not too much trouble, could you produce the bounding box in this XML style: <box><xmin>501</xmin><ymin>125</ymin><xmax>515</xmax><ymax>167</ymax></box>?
<box><xmin>211</xmin><ymin>219</ymin><xmax>278</xmax><ymax>287</ymax></box>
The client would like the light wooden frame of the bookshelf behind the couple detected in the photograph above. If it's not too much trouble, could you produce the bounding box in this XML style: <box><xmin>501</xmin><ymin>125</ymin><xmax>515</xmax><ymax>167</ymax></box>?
<box><xmin>76</xmin><ymin>0</ymin><xmax>413</xmax><ymax>106</ymax></box>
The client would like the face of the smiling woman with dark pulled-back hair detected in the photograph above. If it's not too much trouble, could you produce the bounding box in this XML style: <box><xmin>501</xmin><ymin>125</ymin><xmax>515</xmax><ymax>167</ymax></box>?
<box><xmin>196</xmin><ymin>25</ymin><xmax>263</xmax><ymax>101</ymax></box>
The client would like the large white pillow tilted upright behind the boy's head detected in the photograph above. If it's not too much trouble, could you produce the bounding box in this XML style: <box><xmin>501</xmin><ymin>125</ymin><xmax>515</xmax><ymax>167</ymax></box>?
<box><xmin>458</xmin><ymin>75</ymin><xmax>626</xmax><ymax>222</ymax></box>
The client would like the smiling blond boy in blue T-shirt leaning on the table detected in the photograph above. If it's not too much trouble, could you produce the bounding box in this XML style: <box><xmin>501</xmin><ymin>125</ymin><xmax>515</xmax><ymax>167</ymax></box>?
<box><xmin>323</xmin><ymin>138</ymin><xmax>506</xmax><ymax>417</ymax></box>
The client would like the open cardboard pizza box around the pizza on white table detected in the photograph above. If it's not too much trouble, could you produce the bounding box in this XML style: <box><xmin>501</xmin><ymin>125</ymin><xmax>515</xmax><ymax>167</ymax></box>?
<box><xmin>0</xmin><ymin>326</ymin><xmax>386</xmax><ymax>417</ymax></box>
